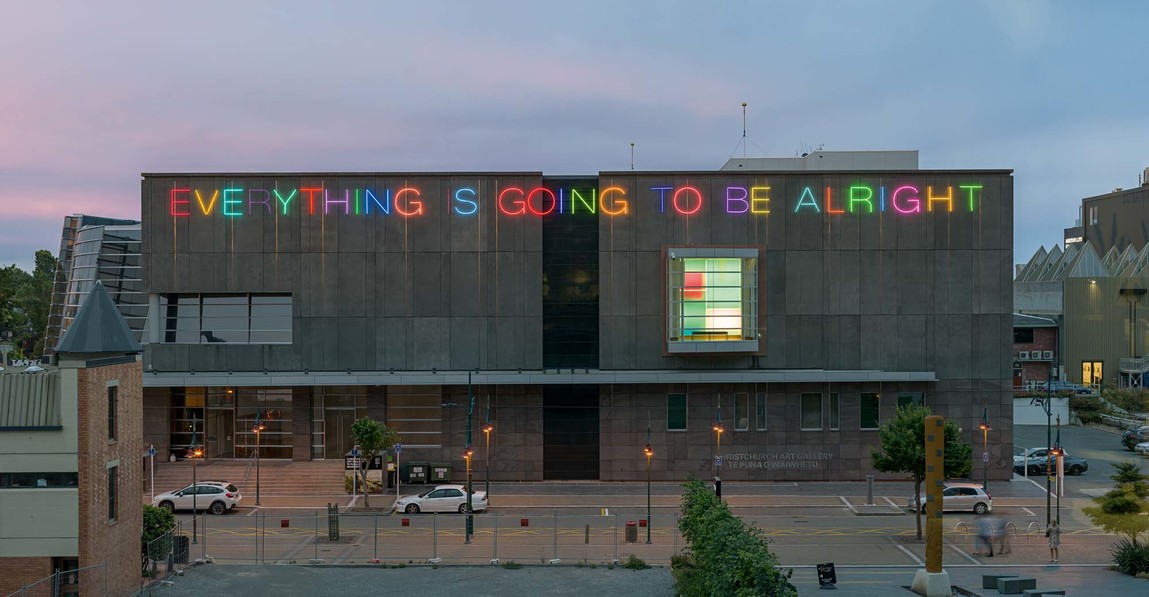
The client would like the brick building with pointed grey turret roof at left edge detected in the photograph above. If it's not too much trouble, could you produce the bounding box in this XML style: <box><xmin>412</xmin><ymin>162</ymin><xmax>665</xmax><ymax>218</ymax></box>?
<box><xmin>0</xmin><ymin>284</ymin><xmax>144</xmax><ymax>595</ymax></box>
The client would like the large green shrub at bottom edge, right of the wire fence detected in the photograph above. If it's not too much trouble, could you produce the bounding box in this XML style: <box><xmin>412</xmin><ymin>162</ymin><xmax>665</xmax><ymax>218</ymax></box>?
<box><xmin>671</xmin><ymin>478</ymin><xmax>797</xmax><ymax>597</ymax></box>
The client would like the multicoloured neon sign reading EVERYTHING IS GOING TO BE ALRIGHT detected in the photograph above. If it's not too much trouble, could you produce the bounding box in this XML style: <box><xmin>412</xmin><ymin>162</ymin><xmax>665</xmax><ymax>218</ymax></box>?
<box><xmin>168</xmin><ymin>184</ymin><xmax>982</xmax><ymax>218</ymax></box>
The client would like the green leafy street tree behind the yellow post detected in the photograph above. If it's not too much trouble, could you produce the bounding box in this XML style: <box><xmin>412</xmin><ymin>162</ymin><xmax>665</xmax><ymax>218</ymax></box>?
<box><xmin>870</xmin><ymin>404</ymin><xmax>973</xmax><ymax>538</ymax></box>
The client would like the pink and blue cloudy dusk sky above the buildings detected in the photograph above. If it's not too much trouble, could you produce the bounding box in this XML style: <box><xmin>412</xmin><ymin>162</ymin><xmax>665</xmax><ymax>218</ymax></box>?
<box><xmin>0</xmin><ymin>0</ymin><xmax>1149</xmax><ymax>270</ymax></box>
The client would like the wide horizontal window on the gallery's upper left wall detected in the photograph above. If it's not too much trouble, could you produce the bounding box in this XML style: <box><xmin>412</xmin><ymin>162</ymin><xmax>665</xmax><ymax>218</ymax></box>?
<box><xmin>160</xmin><ymin>294</ymin><xmax>292</xmax><ymax>344</ymax></box>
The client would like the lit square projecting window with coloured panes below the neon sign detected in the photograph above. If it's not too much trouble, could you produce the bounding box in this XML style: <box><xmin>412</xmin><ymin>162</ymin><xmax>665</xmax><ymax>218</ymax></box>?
<box><xmin>666</xmin><ymin>248</ymin><xmax>759</xmax><ymax>352</ymax></box>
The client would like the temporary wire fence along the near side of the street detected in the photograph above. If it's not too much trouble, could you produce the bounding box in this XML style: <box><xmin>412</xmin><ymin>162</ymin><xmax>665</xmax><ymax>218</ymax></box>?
<box><xmin>147</xmin><ymin>510</ymin><xmax>685</xmax><ymax>567</ymax></box>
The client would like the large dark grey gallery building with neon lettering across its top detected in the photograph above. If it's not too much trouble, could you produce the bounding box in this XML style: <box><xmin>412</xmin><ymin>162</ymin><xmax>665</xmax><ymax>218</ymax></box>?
<box><xmin>141</xmin><ymin>152</ymin><xmax>1013</xmax><ymax>481</ymax></box>
